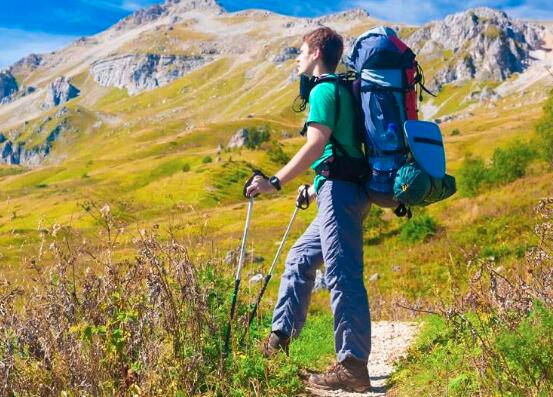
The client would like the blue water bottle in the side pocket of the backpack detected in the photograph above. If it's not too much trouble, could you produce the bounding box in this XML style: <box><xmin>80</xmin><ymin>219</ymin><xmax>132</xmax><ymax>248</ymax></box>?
<box><xmin>369</xmin><ymin>123</ymin><xmax>399</xmax><ymax>193</ymax></box>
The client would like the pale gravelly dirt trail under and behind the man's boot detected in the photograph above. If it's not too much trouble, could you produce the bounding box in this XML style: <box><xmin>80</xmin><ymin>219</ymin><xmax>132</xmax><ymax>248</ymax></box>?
<box><xmin>308</xmin><ymin>321</ymin><xmax>419</xmax><ymax>397</ymax></box>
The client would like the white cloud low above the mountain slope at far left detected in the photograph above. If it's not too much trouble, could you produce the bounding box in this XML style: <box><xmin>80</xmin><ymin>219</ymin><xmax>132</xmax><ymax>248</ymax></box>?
<box><xmin>0</xmin><ymin>28</ymin><xmax>77</xmax><ymax>69</ymax></box>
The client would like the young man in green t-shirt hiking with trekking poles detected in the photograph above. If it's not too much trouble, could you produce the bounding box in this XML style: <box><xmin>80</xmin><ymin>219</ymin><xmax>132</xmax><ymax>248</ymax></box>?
<box><xmin>246</xmin><ymin>27</ymin><xmax>371</xmax><ymax>392</ymax></box>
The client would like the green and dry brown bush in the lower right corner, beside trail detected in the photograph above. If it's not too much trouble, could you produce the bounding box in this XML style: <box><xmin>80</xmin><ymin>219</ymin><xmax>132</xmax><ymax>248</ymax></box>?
<box><xmin>393</xmin><ymin>198</ymin><xmax>553</xmax><ymax>397</ymax></box>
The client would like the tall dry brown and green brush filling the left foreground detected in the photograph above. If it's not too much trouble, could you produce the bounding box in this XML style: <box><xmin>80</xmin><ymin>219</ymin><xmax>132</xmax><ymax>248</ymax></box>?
<box><xmin>0</xmin><ymin>202</ymin><xmax>304</xmax><ymax>397</ymax></box>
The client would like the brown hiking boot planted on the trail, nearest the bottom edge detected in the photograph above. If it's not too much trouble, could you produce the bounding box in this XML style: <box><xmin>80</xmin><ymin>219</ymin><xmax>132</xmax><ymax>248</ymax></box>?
<box><xmin>308</xmin><ymin>358</ymin><xmax>371</xmax><ymax>393</ymax></box>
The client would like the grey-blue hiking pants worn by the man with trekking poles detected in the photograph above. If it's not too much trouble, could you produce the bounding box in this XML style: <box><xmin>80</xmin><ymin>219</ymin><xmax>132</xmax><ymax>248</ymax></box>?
<box><xmin>272</xmin><ymin>181</ymin><xmax>371</xmax><ymax>362</ymax></box>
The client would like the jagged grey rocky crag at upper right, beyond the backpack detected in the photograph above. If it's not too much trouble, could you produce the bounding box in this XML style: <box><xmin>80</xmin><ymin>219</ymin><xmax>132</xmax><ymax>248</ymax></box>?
<box><xmin>407</xmin><ymin>7</ymin><xmax>544</xmax><ymax>87</ymax></box>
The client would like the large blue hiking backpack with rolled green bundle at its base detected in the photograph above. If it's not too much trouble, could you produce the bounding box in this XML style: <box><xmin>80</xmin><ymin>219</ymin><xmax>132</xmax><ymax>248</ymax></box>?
<box><xmin>345</xmin><ymin>27</ymin><xmax>456</xmax><ymax>217</ymax></box>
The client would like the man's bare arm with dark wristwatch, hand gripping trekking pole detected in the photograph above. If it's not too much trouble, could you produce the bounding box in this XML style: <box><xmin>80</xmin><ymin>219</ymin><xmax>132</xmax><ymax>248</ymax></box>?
<box><xmin>246</xmin><ymin>123</ymin><xmax>332</xmax><ymax>196</ymax></box>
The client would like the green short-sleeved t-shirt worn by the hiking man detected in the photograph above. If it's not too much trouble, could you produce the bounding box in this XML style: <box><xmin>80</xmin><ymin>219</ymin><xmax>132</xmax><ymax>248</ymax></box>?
<box><xmin>306</xmin><ymin>77</ymin><xmax>363</xmax><ymax>192</ymax></box>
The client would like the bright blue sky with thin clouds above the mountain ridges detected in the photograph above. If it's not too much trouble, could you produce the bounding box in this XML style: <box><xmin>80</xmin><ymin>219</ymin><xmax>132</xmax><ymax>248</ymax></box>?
<box><xmin>0</xmin><ymin>0</ymin><xmax>553</xmax><ymax>69</ymax></box>
